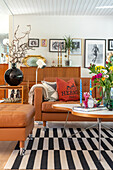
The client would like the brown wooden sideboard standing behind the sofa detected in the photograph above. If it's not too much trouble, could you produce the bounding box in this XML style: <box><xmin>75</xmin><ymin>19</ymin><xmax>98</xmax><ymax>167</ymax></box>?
<box><xmin>20</xmin><ymin>67</ymin><xmax>81</xmax><ymax>87</ymax></box>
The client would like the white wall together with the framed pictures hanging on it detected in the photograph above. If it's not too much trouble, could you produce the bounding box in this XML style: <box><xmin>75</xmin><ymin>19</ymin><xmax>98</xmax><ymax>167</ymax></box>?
<box><xmin>9</xmin><ymin>15</ymin><xmax>113</xmax><ymax>77</ymax></box>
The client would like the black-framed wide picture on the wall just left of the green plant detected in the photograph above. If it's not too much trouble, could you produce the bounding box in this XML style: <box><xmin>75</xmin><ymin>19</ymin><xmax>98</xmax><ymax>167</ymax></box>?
<box><xmin>49</xmin><ymin>39</ymin><xmax>65</xmax><ymax>53</ymax></box>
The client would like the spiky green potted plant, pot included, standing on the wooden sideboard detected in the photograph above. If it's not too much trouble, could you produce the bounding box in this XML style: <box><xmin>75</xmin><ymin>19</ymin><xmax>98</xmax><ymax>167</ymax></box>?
<box><xmin>64</xmin><ymin>36</ymin><xmax>75</xmax><ymax>66</ymax></box>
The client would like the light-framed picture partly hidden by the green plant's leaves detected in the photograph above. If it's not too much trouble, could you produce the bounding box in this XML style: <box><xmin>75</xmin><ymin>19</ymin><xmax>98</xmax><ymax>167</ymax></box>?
<box><xmin>70</xmin><ymin>38</ymin><xmax>82</xmax><ymax>55</ymax></box>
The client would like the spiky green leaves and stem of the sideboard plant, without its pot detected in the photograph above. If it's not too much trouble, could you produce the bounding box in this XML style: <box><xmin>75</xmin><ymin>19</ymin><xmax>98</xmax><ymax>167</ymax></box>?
<box><xmin>64</xmin><ymin>36</ymin><xmax>75</xmax><ymax>60</ymax></box>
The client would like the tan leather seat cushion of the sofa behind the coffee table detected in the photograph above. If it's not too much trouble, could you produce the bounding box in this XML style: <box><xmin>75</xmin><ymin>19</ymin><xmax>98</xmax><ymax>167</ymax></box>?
<box><xmin>42</xmin><ymin>101</ymin><xmax>80</xmax><ymax>113</ymax></box>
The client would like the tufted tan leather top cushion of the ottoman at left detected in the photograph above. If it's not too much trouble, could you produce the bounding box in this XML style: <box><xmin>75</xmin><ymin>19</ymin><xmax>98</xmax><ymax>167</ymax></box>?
<box><xmin>0</xmin><ymin>104</ymin><xmax>35</xmax><ymax>127</ymax></box>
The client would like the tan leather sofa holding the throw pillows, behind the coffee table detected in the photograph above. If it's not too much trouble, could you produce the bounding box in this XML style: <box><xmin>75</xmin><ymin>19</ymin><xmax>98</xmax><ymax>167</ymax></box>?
<box><xmin>34</xmin><ymin>77</ymin><xmax>101</xmax><ymax>126</ymax></box>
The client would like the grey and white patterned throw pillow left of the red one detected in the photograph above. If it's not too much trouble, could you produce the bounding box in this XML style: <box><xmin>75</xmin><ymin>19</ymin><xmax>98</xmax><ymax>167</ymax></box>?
<box><xmin>41</xmin><ymin>81</ymin><xmax>58</xmax><ymax>101</ymax></box>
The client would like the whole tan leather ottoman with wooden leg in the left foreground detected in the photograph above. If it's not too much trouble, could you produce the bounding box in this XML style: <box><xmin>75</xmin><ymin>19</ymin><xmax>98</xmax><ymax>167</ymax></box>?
<box><xmin>0</xmin><ymin>104</ymin><xmax>35</xmax><ymax>155</ymax></box>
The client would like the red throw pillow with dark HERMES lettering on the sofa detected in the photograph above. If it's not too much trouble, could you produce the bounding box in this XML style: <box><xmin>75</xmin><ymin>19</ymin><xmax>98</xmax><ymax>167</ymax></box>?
<box><xmin>57</xmin><ymin>78</ymin><xmax>79</xmax><ymax>101</ymax></box>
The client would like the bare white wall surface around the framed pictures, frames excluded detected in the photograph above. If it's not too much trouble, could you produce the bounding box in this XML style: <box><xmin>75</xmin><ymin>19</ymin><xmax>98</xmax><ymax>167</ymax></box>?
<box><xmin>10</xmin><ymin>15</ymin><xmax>113</xmax><ymax>76</ymax></box>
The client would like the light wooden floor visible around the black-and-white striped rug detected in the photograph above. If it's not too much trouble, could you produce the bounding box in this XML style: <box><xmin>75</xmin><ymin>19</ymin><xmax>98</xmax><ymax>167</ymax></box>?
<box><xmin>0</xmin><ymin>122</ymin><xmax>113</xmax><ymax>170</ymax></box>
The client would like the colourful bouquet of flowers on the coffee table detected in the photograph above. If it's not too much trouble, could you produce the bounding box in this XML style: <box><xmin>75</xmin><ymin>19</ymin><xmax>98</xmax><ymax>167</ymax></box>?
<box><xmin>89</xmin><ymin>53</ymin><xmax>113</xmax><ymax>109</ymax></box>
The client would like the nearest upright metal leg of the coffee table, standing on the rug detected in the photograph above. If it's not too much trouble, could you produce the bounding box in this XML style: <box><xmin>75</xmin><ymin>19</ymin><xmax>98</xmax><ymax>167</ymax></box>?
<box><xmin>97</xmin><ymin>118</ymin><xmax>101</xmax><ymax>161</ymax></box>
